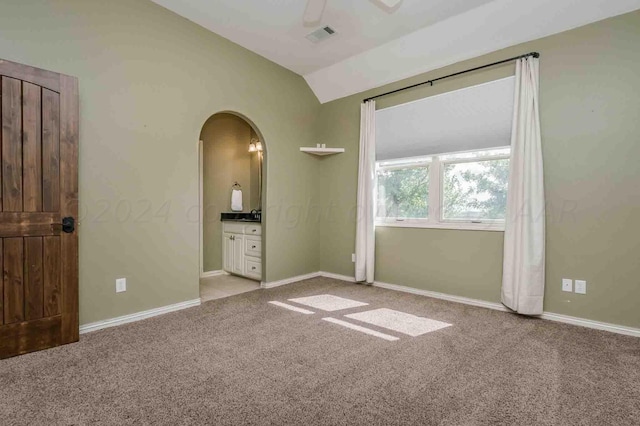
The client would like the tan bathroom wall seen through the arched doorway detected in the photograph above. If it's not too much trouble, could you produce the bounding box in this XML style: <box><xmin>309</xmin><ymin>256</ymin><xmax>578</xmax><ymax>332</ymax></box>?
<box><xmin>200</xmin><ymin>114</ymin><xmax>259</xmax><ymax>272</ymax></box>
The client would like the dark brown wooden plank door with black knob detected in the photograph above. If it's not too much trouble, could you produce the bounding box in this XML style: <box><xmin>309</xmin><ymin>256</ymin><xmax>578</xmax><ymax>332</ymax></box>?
<box><xmin>0</xmin><ymin>60</ymin><xmax>79</xmax><ymax>358</ymax></box>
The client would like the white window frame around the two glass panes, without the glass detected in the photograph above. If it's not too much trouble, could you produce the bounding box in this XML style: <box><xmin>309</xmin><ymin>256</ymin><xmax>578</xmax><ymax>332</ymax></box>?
<box><xmin>375</xmin><ymin>147</ymin><xmax>510</xmax><ymax>232</ymax></box>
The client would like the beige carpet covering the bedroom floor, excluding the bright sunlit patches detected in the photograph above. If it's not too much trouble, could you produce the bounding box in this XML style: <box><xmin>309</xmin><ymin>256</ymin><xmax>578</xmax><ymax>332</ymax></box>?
<box><xmin>0</xmin><ymin>278</ymin><xmax>640</xmax><ymax>425</ymax></box>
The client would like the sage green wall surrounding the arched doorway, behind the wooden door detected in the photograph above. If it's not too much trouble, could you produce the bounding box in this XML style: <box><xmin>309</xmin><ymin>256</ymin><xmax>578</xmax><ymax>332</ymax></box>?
<box><xmin>0</xmin><ymin>0</ymin><xmax>320</xmax><ymax>324</ymax></box>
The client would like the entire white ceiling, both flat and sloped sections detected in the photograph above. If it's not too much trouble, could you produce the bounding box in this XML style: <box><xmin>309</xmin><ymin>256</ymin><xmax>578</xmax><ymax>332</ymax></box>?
<box><xmin>152</xmin><ymin>0</ymin><xmax>640</xmax><ymax>103</ymax></box>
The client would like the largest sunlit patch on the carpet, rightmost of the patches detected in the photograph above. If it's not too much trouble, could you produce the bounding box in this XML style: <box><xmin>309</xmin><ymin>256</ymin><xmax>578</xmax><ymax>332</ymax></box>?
<box><xmin>345</xmin><ymin>308</ymin><xmax>451</xmax><ymax>337</ymax></box>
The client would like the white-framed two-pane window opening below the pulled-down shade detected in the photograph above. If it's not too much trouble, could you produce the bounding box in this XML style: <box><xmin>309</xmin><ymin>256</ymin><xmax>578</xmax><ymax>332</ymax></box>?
<box><xmin>376</xmin><ymin>148</ymin><xmax>509</xmax><ymax>230</ymax></box>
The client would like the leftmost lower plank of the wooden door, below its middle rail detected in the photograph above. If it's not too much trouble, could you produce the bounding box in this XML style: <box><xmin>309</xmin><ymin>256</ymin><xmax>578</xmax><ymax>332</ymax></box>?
<box><xmin>2</xmin><ymin>238</ymin><xmax>24</xmax><ymax>324</ymax></box>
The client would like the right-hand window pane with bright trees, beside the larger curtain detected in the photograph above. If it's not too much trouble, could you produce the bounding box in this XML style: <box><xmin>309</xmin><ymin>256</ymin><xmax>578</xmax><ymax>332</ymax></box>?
<box><xmin>442</xmin><ymin>159</ymin><xmax>509</xmax><ymax>220</ymax></box>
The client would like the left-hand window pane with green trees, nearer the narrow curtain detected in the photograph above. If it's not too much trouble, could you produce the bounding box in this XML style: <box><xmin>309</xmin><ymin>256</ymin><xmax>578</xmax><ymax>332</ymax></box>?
<box><xmin>376</xmin><ymin>166</ymin><xmax>429</xmax><ymax>219</ymax></box>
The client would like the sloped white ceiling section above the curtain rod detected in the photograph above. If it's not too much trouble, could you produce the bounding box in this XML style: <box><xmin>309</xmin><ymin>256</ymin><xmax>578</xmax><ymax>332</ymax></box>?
<box><xmin>304</xmin><ymin>0</ymin><xmax>640</xmax><ymax>103</ymax></box>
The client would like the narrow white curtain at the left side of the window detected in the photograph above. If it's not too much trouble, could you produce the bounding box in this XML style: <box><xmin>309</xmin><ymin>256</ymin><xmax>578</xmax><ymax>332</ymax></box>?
<box><xmin>356</xmin><ymin>101</ymin><xmax>376</xmax><ymax>283</ymax></box>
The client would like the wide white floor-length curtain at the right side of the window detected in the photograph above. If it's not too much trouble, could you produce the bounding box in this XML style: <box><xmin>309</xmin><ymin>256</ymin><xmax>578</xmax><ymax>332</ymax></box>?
<box><xmin>502</xmin><ymin>56</ymin><xmax>545</xmax><ymax>315</ymax></box>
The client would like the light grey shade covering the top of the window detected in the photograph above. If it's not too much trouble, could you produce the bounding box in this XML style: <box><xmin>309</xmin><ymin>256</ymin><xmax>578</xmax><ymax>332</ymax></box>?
<box><xmin>376</xmin><ymin>77</ymin><xmax>515</xmax><ymax>160</ymax></box>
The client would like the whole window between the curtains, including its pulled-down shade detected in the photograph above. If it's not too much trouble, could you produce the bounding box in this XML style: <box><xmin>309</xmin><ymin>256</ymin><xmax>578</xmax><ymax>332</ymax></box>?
<box><xmin>376</xmin><ymin>77</ymin><xmax>515</xmax><ymax>231</ymax></box>
